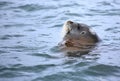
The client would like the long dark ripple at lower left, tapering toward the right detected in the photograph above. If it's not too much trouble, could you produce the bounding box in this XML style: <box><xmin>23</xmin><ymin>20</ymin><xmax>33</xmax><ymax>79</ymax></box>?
<box><xmin>0</xmin><ymin>64</ymin><xmax>55</xmax><ymax>72</ymax></box>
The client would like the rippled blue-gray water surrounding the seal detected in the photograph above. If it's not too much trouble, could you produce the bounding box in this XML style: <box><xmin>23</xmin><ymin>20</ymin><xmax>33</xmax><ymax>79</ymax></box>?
<box><xmin>0</xmin><ymin>0</ymin><xmax>120</xmax><ymax>81</ymax></box>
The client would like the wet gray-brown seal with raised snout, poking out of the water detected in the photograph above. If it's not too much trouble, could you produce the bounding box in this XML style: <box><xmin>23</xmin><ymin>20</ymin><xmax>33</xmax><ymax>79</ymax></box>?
<box><xmin>59</xmin><ymin>21</ymin><xmax>99</xmax><ymax>53</ymax></box>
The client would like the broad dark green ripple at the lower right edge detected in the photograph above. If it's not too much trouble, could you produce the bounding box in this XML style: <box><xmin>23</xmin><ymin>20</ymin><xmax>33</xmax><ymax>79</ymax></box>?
<box><xmin>85</xmin><ymin>64</ymin><xmax>120</xmax><ymax>76</ymax></box>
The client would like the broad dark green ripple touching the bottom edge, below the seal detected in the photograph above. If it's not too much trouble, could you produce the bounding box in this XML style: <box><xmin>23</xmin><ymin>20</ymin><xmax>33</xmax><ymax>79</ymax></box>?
<box><xmin>32</xmin><ymin>72</ymin><xmax>87</xmax><ymax>81</ymax></box>
